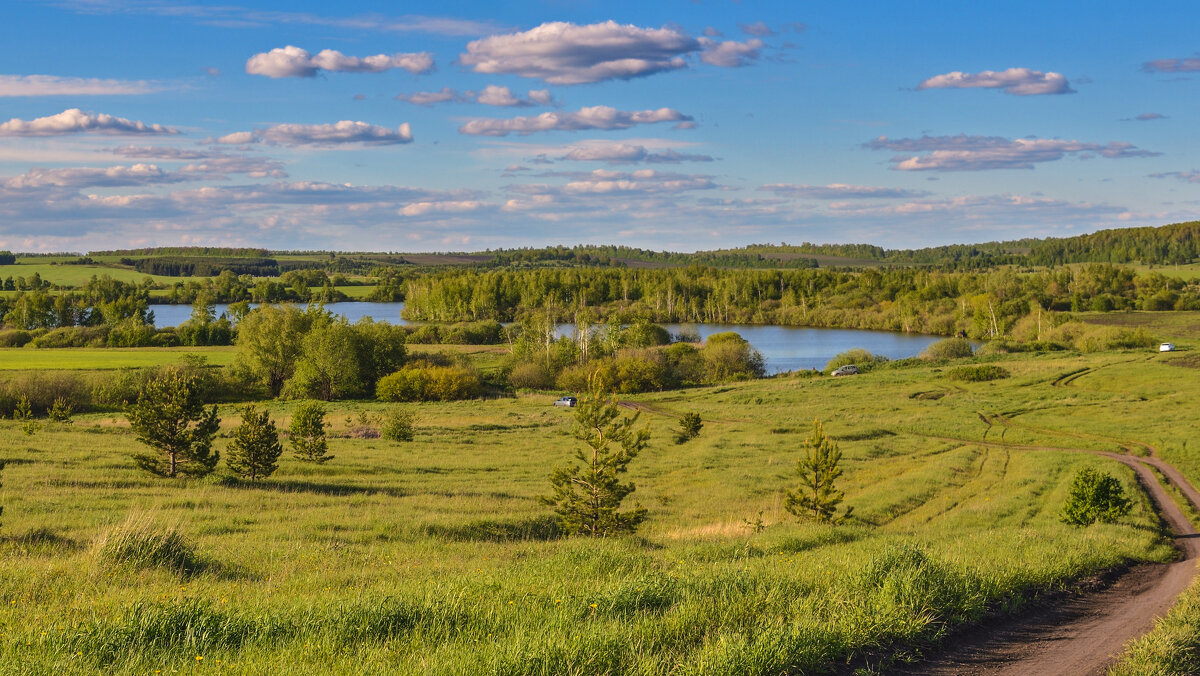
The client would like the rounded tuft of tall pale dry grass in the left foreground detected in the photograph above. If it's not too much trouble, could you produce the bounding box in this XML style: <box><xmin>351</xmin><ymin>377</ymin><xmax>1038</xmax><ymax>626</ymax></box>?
<box><xmin>95</xmin><ymin>513</ymin><xmax>203</xmax><ymax>573</ymax></box>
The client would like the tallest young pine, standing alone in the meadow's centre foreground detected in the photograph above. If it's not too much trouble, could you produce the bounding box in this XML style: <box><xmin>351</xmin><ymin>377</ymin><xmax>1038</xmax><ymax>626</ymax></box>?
<box><xmin>542</xmin><ymin>389</ymin><xmax>650</xmax><ymax>537</ymax></box>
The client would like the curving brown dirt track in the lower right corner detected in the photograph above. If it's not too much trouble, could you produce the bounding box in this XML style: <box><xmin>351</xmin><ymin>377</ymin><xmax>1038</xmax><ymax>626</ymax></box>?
<box><xmin>893</xmin><ymin>444</ymin><xmax>1200</xmax><ymax>676</ymax></box>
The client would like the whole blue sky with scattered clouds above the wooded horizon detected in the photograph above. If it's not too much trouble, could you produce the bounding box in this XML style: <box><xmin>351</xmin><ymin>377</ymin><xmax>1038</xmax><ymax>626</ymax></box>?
<box><xmin>0</xmin><ymin>0</ymin><xmax>1200</xmax><ymax>251</ymax></box>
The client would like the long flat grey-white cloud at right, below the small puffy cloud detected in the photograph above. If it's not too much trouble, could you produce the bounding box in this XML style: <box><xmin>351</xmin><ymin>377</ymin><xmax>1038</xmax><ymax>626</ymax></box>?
<box><xmin>865</xmin><ymin>134</ymin><xmax>1159</xmax><ymax>172</ymax></box>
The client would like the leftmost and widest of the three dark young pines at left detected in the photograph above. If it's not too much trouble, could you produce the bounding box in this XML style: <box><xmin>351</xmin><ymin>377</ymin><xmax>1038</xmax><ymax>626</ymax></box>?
<box><xmin>125</xmin><ymin>372</ymin><xmax>221</xmax><ymax>477</ymax></box>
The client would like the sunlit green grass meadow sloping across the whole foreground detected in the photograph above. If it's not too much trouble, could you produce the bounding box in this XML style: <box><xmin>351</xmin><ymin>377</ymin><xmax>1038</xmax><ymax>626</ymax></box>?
<box><xmin>0</xmin><ymin>346</ymin><xmax>1200</xmax><ymax>675</ymax></box>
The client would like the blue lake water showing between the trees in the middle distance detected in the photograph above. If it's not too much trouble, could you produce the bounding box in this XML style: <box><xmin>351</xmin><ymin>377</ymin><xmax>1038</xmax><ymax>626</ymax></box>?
<box><xmin>150</xmin><ymin>303</ymin><xmax>942</xmax><ymax>373</ymax></box>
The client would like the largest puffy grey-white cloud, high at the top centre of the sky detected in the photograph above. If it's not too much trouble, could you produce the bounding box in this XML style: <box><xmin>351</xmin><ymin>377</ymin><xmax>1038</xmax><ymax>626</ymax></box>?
<box><xmin>458</xmin><ymin>20</ymin><xmax>701</xmax><ymax>84</ymax></box>
